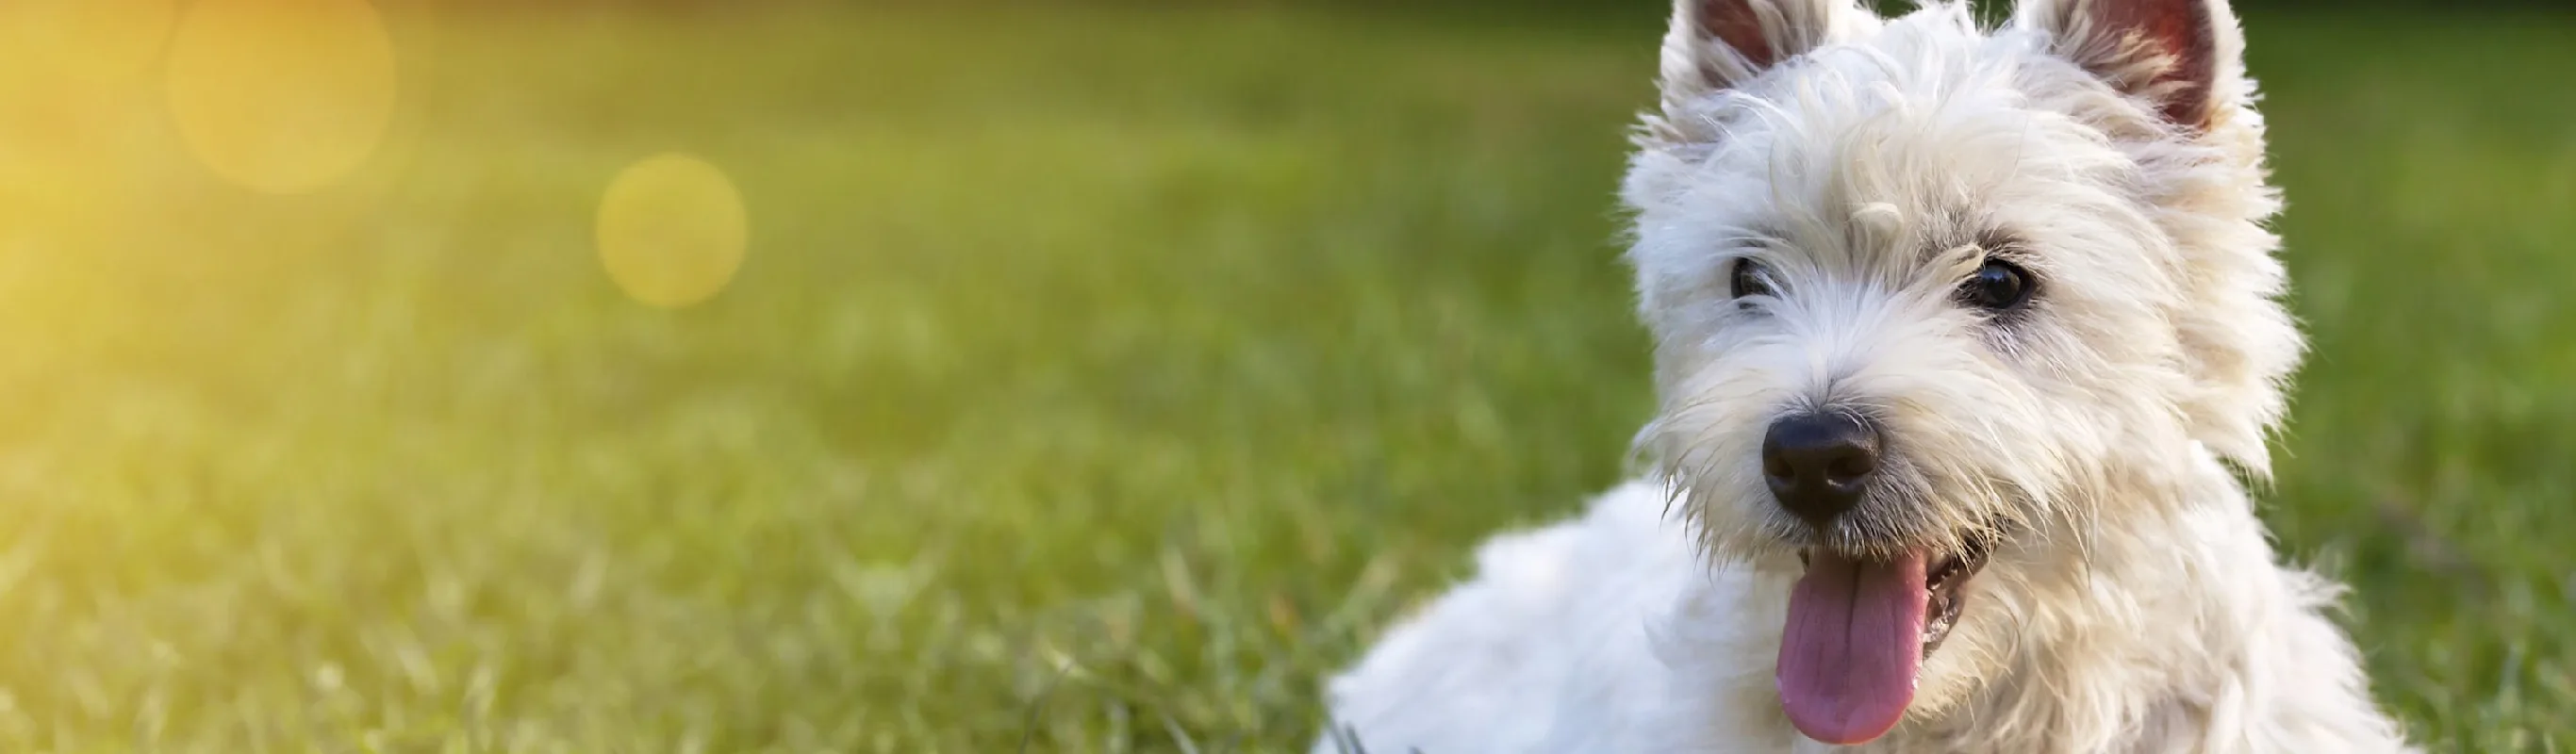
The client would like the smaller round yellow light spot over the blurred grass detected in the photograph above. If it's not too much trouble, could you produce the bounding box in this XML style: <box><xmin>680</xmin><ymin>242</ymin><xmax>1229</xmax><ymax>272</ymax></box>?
<box><xmin>598</xmin><ymin>155</ymin><xmax>750</xmax><ymax>309</ymax></box>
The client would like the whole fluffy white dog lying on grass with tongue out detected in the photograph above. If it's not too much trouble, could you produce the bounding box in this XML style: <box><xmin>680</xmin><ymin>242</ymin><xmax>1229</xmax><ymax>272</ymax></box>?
<box><xmin>1316</xmin><ymin>0</ymin><xmax>2411</xmax><ymax>754</ymax></box>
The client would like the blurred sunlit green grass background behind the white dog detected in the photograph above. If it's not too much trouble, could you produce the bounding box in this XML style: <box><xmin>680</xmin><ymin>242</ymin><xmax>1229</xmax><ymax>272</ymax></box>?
<box><xmin>0</xmin><ymin>0</ymin><xmax>2576</xmax><ymax>751</ymax></box>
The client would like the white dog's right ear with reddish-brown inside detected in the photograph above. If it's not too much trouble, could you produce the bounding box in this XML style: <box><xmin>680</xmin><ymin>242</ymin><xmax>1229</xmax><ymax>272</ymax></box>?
<box><xmin>2014</xmin><ymin>0</ymin><xmax>2244</xmax><ymax>129</ymax></box>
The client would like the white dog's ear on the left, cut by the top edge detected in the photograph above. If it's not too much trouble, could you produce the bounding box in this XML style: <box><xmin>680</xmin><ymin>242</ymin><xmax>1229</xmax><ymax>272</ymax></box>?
<box><xmin>1661</xmin><ymin>0</ymin><xmax>1878</xmax><ymax>116</ymax></box>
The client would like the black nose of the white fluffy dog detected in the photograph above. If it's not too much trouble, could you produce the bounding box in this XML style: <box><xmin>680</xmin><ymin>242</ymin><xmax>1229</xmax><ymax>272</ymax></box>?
<box><xmin>1762</xmin><ymin>412</ymin><xmax>1878</xmax><ymax>528</ymax></box>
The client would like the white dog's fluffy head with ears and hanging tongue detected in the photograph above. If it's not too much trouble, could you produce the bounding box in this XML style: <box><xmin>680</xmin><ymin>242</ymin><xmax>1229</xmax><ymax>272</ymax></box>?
<box><xmin>1623</xmin><ymin>0</ymin><xmax>2301</xmax><ymax>744</ymax></box>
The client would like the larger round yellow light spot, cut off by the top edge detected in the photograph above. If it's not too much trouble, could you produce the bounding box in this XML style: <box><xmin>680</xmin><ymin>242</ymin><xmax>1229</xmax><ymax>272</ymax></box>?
<box><xmin>170</xmin><ymin>0</ymin><xmax>394</xmax><ymax>193</ymax></box>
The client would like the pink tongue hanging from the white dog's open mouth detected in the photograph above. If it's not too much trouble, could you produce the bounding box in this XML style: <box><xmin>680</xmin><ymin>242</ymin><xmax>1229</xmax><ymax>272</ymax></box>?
<box><xmin>1777</xmin><ymin>550</ymin><xmax>1932</xmax><ymax>744</ymax></box>
